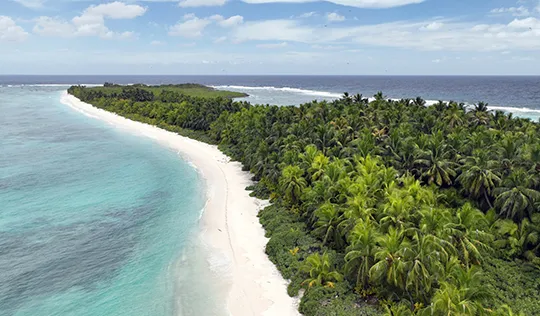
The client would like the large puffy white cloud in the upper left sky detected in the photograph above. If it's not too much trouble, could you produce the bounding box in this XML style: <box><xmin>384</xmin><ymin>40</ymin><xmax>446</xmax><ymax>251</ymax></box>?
<box><xmin>33</xmin><ymin>1</ymin><xmax>146</xmax><ymax>39</ymax></box>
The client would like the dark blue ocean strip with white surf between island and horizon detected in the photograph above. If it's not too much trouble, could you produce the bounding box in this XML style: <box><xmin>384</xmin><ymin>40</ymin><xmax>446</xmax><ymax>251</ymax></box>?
<box><xmin>0</xmin><ymin>75</ymin><xmax>540</xmax><ymax>111</ymax></box>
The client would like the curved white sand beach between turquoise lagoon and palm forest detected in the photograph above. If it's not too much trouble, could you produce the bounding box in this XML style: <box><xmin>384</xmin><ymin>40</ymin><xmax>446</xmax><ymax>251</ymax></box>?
<box><xmin>61</xmin><ymin>92</ymin><xmax>299</xmax><ymax>316</ymax></box>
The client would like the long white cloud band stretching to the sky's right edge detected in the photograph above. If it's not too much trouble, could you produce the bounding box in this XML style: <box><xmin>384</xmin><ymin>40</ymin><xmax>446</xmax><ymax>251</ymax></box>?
<box><xmin>231</xmin><ymin>18</ymin><xmax>540</xmax><ymax>52</ymax></box>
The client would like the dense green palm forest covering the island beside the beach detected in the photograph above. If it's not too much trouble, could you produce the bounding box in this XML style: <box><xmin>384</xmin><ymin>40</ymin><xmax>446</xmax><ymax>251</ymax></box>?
<box><xmin>69</xmin><ymin>86</ymin><xmax>540</xmax><ymax>315</ymax></box>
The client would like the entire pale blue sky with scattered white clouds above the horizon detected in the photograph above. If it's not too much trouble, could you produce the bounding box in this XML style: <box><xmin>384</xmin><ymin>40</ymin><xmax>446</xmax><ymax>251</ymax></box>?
<box><xmin>0</xmin><ymin>0</ymin><xmax>540</xmax><ymax>75</ymax></box>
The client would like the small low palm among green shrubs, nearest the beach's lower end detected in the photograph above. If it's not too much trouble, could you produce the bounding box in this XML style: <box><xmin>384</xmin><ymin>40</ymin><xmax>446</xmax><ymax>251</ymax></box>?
<box><xmin>302</xmin><ymin>252</ymin><xmax>343</xmax><ymax>289</ymax></box>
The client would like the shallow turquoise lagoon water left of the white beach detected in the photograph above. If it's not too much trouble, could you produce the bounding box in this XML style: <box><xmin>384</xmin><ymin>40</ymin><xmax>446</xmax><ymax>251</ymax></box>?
<box><xmin>0</xmin><ymin>87</ymin><xmax>216</xmax><ymax>316</ymax></box>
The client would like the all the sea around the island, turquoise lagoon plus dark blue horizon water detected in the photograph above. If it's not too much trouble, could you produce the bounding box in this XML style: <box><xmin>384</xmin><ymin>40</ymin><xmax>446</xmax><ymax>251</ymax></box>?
<box><xmin>0</xmin><ymin>76</ymin><xmax>540</xmax><ymax>316</ymax></box>
